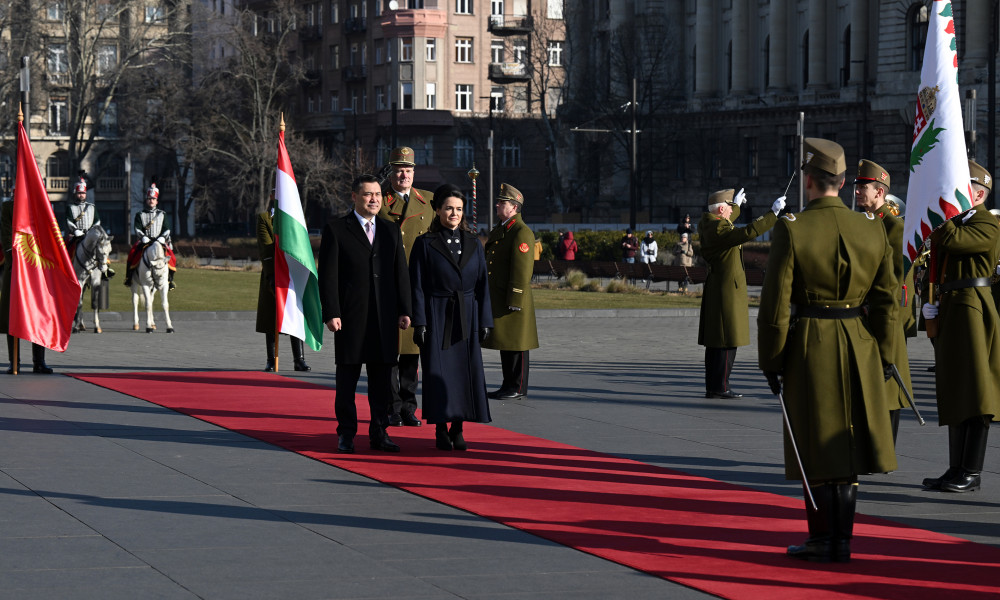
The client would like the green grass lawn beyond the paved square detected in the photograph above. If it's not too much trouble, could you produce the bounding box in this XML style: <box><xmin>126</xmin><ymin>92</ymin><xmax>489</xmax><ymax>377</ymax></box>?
<box><xmin>95</xmin><ymin>262</ymin><xmax>720</xmax><ymax>313</ymax></box>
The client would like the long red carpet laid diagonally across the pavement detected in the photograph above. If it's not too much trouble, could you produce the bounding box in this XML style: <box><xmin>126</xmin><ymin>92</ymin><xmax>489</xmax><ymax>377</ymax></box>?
<box><xmin>74</xmin><ymin>372</ymin><xmax>1000</xmax><ymax>600</ymax></box>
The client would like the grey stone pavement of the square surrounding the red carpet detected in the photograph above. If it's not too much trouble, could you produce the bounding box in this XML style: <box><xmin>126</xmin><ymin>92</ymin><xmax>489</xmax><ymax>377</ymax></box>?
<box><xmin>0</xmin><ymin>310</ymin><xmax>1000</xmax><ymax>600</ymax></box>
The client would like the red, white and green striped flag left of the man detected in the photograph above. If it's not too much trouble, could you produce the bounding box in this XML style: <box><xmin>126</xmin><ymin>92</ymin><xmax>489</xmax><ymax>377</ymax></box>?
<box><xmin>274</xmin><ymin>126</ymin><xmax>323</xmax><ymax>352</ymax></box>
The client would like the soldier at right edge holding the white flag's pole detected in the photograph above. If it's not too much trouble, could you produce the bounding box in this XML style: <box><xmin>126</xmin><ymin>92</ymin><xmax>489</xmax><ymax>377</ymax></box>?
<box><xmin>922</xmin><ymin>160</ymin><xmax>1000</xmax><ymax>492</ymax></box>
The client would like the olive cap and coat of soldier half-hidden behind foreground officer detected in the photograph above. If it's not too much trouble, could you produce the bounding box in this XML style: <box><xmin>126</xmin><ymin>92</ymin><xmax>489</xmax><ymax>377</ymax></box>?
<box><xmin>854</xmin><ymin>160</ymin><xmax>913</xmax><ymax>441</ymax></box>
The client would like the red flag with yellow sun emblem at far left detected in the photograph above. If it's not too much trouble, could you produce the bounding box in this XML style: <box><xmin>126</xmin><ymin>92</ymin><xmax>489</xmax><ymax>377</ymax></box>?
<box><xmin>8</xmin><ymin>122</ymin><xmax>80</xmax><ymax>352</ymax></box>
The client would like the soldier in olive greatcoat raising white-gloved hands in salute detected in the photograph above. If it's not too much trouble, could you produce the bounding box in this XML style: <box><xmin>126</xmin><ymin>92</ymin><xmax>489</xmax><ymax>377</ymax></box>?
<box><xmin>698</xmin><ymin>189</ymin><xmax>785</xmax><ymax>398</ymax></box>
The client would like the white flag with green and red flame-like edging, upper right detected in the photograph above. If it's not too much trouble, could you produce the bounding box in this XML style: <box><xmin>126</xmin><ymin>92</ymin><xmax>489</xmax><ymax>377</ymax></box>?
<box><xmin>903</xmin><ymin>0</ymin><xmax>972</xmax><ymax>270</ymax></box>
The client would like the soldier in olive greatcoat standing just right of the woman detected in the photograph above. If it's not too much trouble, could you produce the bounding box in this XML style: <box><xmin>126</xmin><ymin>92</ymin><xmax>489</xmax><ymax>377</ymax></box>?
<box><xmin>483</xmin><ymin>183</ymin><xmax>538</xmax><ymax>400</ymax></box>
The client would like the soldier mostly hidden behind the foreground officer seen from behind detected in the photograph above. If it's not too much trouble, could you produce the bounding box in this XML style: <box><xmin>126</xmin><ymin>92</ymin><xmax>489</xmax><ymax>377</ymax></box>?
<box><xmin>854</xmin><ymin>160</ymin><xmax>913</xmax><ymax>443</ymax></box>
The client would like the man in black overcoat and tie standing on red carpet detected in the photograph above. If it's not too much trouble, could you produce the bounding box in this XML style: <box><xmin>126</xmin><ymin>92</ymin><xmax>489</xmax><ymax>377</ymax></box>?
<box><xmin>319</xmin><ymin>175</ymin><xmax>412</xmax><ymax>453</ymax></box>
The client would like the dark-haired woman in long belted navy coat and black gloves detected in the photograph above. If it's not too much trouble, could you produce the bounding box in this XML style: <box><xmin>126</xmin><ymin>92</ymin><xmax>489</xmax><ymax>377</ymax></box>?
<box><xmin>410</xmin><ymin>184</ymin><xmax>493</xmax><ymax>450</ymax></box>
